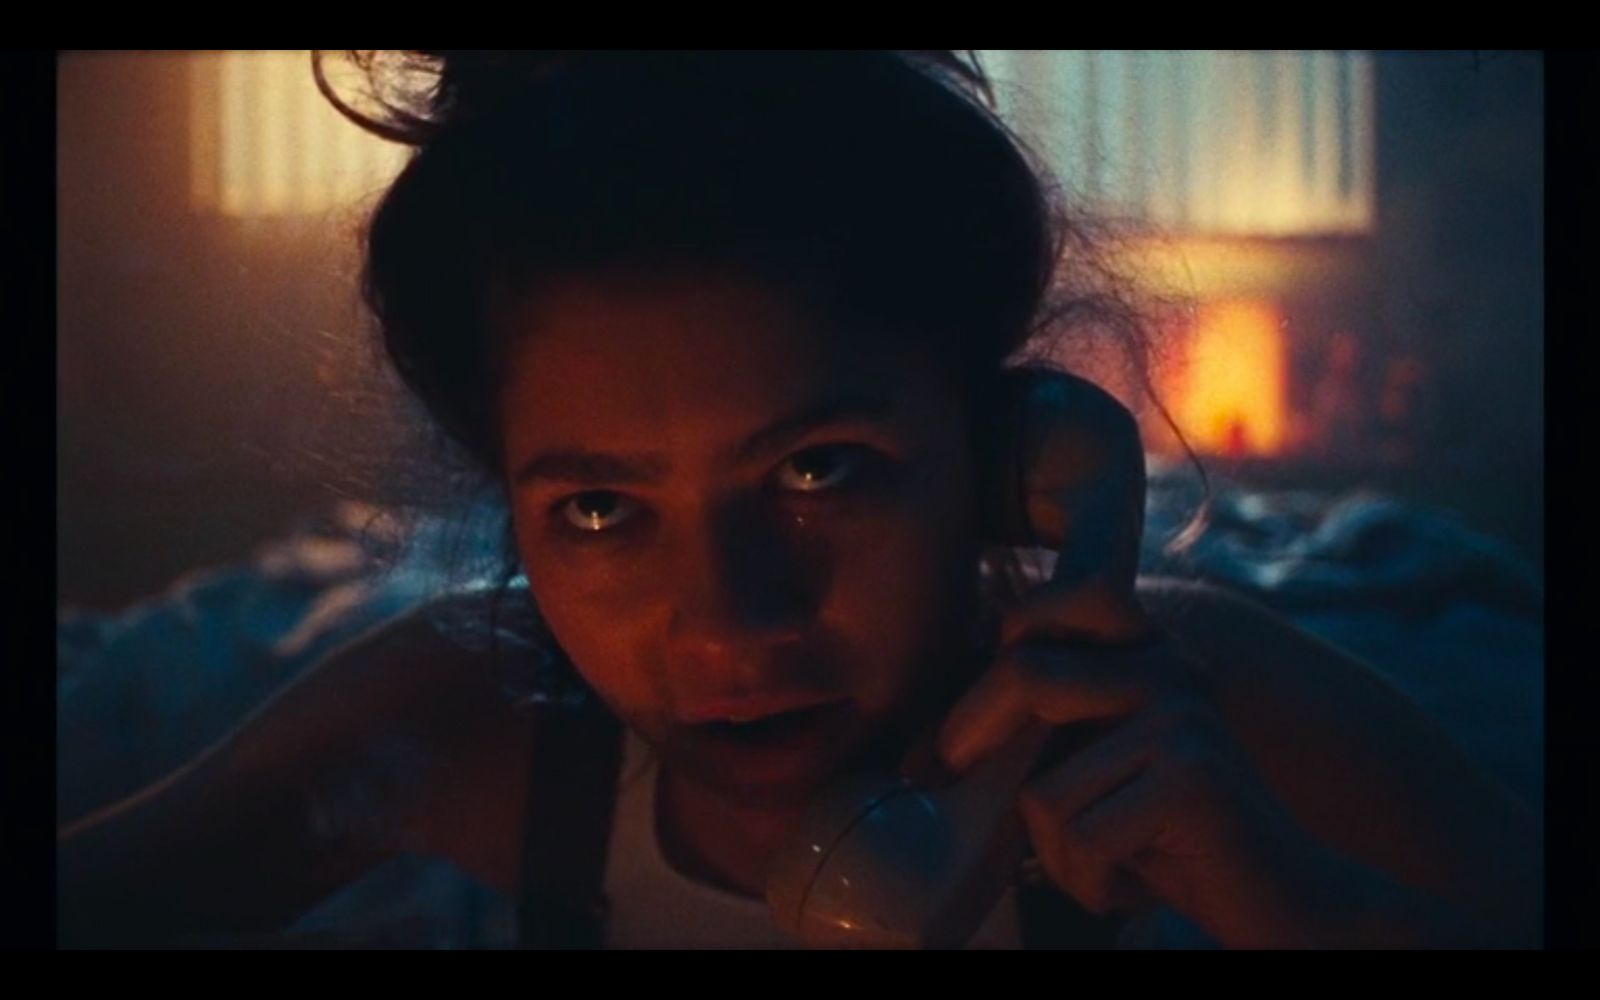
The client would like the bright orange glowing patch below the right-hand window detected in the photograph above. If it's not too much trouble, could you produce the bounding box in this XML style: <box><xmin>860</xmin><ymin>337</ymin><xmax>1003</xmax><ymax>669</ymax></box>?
<box><xmin>1165</xmin><ymin>299</ymin><xmax>1290</xmax><ymax>458</ymax></box>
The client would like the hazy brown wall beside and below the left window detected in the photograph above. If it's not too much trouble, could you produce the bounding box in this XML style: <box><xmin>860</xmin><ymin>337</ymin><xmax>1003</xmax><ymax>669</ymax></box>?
<box><xmin>58</xmin><ymin>53</ymin><xmax>384</xmax><ymax>605</ymax></box>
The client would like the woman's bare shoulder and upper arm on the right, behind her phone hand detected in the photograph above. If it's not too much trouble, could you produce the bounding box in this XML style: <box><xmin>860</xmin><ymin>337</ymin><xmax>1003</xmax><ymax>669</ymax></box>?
<box><xmin>1138</xmin><ymin>578</ymin><xmax>1541</xmax><ymax>946</ymax></box>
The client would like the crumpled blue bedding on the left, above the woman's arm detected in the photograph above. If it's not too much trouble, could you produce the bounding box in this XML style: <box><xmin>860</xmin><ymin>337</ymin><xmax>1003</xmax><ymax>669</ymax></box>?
<box><xmin>56</xmin><ymin>514</ymin><xmax>429</xmax><ymax>821</ymax></box>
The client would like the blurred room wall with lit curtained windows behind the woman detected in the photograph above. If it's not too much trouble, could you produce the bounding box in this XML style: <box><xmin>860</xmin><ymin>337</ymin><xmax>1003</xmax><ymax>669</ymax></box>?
<box><xmin>58</xmin><ymin>51</ymin><xmax>1544</xmax><ymax>608</ymax></box>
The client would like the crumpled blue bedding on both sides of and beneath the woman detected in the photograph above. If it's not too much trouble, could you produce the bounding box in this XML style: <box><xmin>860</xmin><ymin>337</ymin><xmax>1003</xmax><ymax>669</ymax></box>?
<box><xmin>56</xmin><ymin>472</ymin><xmax>1544</xmax><ymax>947</ymax></box>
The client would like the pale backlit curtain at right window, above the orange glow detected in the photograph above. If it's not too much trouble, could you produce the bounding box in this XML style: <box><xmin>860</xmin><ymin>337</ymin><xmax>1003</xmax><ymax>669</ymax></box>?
<box><xmin>979</xmin><ymin>50</ymin><xmax>1373</xmax><ymax>237</ymax></box>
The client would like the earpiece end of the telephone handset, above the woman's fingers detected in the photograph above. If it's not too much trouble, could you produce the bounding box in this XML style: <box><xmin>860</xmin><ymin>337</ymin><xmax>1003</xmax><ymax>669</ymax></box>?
<box><xmin>979</xmin><ymin>368</ymin><xmax>1146</xmax><ymax>594</ymax></box>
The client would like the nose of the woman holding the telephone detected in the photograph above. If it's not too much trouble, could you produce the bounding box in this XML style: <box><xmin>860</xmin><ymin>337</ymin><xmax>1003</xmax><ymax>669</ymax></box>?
<box><xmin>667</xmin><ymin>492</ymin><xmax>816</xmax><ymax>665</ymax></box>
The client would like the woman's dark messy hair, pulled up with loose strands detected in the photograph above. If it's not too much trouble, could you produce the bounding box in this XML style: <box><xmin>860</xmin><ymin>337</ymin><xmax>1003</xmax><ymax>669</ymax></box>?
<box><xmin>315</xmin><ymin>50</ymin><xmax>1115</xmax><ymax>475</ymax></box>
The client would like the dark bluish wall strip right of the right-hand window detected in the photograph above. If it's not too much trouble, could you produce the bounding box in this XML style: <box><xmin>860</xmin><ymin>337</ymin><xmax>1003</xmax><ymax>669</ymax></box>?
<box><xmin>1373</xmin><ymin>53</ymin><xmax>1560</xmax><ymax>562</ymax></box>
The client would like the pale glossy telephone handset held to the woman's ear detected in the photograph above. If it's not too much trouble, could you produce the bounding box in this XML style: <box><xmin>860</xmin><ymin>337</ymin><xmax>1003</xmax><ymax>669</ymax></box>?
<box><xmin>766</xmin><ymin>368</ymin><xmax>1144</xmax><ymax>949</ymax></box>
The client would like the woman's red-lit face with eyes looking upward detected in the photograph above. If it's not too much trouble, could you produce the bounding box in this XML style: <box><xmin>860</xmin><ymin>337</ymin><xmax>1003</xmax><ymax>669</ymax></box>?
<box><xmin>502</xmin><ymin>275</ymin><xmax>978</xmax><ymax>802</ymax></box>
